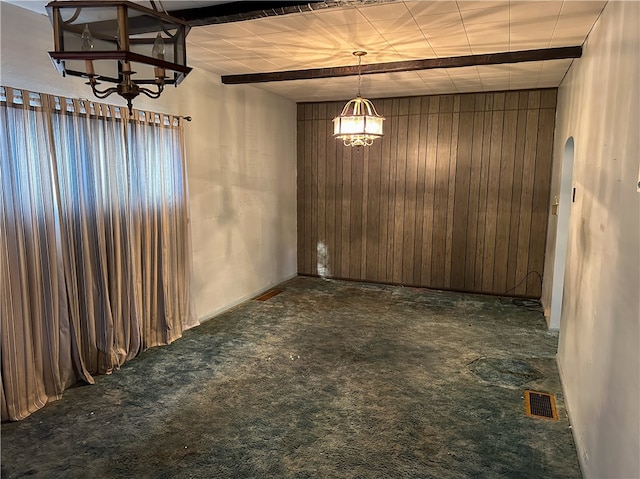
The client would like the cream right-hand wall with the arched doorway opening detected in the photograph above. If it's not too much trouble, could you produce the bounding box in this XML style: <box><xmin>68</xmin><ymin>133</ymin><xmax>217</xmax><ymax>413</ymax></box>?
<box><xmin>542</xmin><ymin>1</ymin><xmax>640</xmax><ymax>479</ymax></box>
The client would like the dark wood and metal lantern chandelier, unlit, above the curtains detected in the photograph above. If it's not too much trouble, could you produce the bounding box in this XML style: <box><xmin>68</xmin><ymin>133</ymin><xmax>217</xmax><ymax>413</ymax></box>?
<box><xmin>47</xmin><ymin>0</ymin><xmax>191</xmax><ymax>113</ymax></box>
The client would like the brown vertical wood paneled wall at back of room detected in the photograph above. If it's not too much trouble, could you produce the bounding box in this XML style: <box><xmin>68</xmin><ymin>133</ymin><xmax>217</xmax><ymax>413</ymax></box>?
<box><xmin>298</xmin><ymin>89</ymin><xmax>557</xmax><ymax>297</ymax></box>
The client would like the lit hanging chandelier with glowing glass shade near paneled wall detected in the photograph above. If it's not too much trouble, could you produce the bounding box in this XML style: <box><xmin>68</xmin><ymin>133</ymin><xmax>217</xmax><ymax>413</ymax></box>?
<box><xmin>333</xmin><ymin>51</ymin><xmax>384</xmax><ymax>146</ymax></box>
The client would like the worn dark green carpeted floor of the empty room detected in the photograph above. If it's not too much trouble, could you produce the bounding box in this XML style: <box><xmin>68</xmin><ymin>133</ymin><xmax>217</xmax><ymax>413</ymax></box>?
<box><xmin>2</xmin><ymin>277</ymin><xmax>581</xmax><ymax>479</ymax></box>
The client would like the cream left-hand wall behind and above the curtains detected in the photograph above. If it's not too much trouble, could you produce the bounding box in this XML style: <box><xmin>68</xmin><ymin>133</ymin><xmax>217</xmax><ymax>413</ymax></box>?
<box><xmin>0</xmin><ymin>2</ymin><xmax>297</xmax><ymax>319</ymax></box>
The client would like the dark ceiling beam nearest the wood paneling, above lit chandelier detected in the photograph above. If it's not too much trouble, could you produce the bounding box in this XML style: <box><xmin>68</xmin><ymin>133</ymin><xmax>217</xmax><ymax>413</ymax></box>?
<box><xmin>222</xmin><ymin>46</ymin><xmax>582</xmax><ymax>85</ymax></box>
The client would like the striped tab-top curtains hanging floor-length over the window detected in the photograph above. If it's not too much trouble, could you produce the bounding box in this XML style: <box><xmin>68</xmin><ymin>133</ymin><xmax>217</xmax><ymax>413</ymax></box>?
<box><xmin>0</xmin><ymin>87</ymin><xmax>194</xmax><ymax>420</ymax></box>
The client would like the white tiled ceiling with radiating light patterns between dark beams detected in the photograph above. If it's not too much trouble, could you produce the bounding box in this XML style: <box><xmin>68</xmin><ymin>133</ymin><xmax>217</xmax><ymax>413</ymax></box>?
<box><xmin>5</xmin><ymin>0</ymin><xmax>607</xmax><ymax>101</ymax></box>
